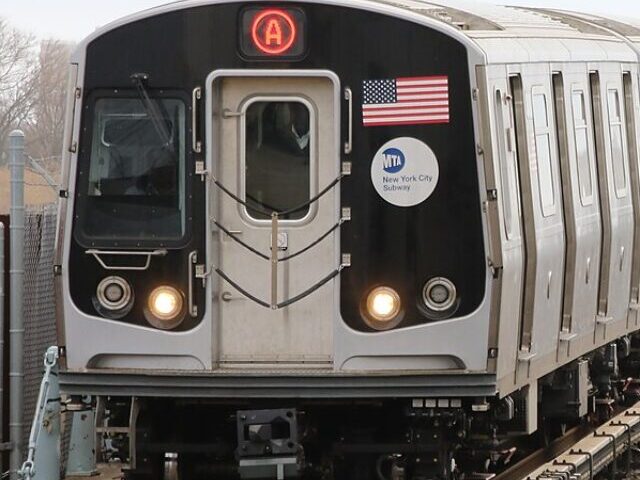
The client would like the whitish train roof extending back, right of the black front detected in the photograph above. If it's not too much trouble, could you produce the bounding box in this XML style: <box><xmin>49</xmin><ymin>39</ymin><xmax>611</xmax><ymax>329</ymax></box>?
<box><xmin>377</xmin><ymin>0</ymin><xmax>640</xmax><ymax>63</ymax></box>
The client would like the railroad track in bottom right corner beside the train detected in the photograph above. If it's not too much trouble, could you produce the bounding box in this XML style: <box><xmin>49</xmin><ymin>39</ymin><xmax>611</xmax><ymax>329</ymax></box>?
<box><xmin>493</xmin><ymin>402</ymin><xmax>640</xmax><ymax>480</ymax></box>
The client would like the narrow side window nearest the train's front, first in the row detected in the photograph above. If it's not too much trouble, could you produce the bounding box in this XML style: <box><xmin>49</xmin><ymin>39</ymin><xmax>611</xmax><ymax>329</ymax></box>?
<box><xmin>495</xmin><ymin>90</ymin><xmax>518</xmax><ymax>239</ymax></box>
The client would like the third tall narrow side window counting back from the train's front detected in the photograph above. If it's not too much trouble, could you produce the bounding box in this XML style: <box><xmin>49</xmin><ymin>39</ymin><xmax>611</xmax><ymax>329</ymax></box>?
<box><xmin>571</xmin><ymin>90</ymin><xmax>593</xmax><ymax>207</ymax></box>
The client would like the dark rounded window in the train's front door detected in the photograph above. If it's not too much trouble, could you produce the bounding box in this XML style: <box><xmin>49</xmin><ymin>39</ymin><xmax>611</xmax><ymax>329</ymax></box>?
<box><xmin>244</xmin><ymin>100</ymin><xmax>314</xmax><ymax>220</ymax></box>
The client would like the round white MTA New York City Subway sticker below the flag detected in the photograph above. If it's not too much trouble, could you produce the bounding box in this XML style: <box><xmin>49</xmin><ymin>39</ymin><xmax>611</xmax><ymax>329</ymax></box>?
<box><xmin>371</xmin><ymin>137</ymin><xmax>440</xmax><ymax>207</ymax></box>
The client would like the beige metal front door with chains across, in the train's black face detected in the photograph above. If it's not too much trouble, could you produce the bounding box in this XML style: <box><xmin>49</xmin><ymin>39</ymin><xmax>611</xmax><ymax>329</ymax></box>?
<box><xmin>211</xmin><ymin>74</ymin><xmax>340</xmax><ymax>368</ymax></box>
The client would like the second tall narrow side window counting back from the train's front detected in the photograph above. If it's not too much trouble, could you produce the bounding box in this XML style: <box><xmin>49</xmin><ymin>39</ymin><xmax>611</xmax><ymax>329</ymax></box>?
<box><xmin>532</xmin><ymin>87</ymin><xmax>556</xmax><ymax>217</ymax></box>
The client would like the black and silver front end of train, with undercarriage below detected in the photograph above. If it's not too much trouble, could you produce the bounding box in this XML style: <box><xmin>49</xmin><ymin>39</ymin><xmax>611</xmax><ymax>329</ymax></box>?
<box><xmin>57</xmin><ymin>1</ymin><xmax>496</xmax><ymax>479</ymax></box>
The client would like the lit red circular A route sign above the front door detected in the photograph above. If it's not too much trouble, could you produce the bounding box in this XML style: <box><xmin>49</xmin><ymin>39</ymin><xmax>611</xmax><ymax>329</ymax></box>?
<box><xmin>251</xmin><ymin>9</ymin><xmax>297</xmax><ymax>55</ymax></box>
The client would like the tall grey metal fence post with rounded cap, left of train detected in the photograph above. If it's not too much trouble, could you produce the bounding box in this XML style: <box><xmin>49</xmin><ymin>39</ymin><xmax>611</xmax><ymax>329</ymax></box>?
<box><xmin>9</xmin><ymin>130</ymin><xmax>24</xmax><ymax>480</ymax></box>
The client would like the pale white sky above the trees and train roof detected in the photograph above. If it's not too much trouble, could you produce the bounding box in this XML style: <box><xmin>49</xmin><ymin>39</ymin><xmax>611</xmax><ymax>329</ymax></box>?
<box><xmin>0</xmin><ymin>0</ymin><xmax>640</xmax><ymax>42</ymax></box>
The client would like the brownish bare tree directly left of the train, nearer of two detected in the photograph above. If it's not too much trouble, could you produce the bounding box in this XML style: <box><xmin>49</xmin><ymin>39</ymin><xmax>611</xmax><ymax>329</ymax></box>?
<box><xmin>26</xmin><ymin>40</ymin><xmax>72</xmax><ymax>158</ymax></box>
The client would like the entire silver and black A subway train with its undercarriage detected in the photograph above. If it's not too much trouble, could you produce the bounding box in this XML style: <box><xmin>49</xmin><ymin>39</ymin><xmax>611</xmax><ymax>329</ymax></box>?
<box><xmin>55</xmin><ymin>0</ymin><xmax>640</xmax><ymax>480</ymax></box>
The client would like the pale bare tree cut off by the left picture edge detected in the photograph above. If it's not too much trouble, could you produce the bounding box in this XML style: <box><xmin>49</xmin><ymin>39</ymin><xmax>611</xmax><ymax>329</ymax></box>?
<box><xmin>0</xmin><ymin>18</ymin><xmax>39</xmax><ymax>162</ymax></box>
